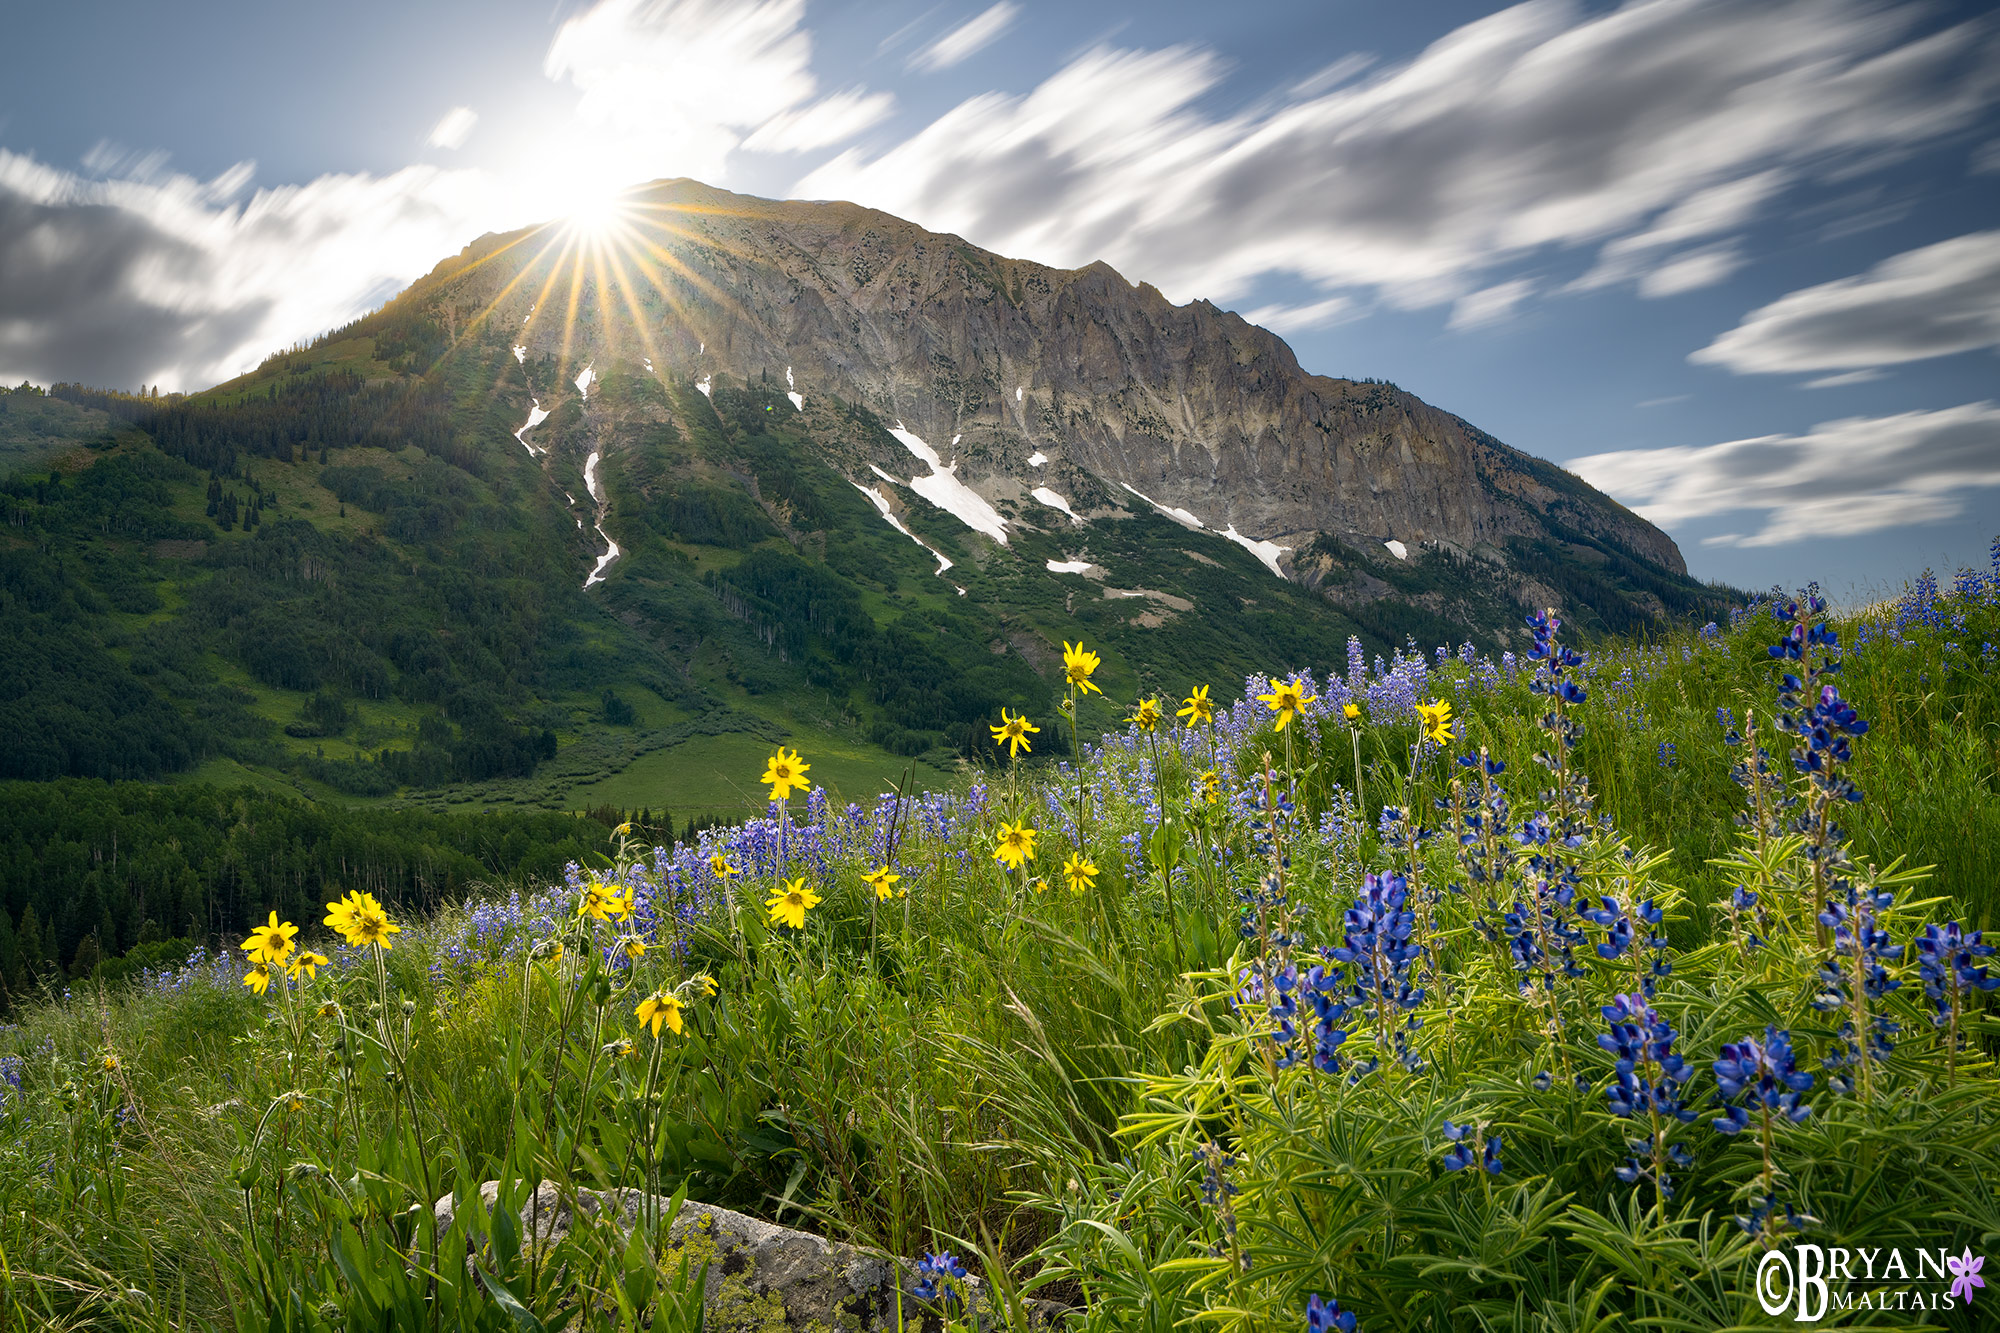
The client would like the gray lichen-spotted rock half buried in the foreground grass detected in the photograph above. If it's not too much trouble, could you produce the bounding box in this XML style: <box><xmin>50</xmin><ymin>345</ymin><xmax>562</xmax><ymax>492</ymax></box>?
<box><xmin>432</xmin><ymin>1181</ymin><xmax>1062</xmax><ymax>1333</ymax></box>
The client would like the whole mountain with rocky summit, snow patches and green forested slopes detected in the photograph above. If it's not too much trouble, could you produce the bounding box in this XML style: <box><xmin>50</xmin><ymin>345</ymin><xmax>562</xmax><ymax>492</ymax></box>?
<box><xmin>0</xmin><ymin>182</ymin><xmax>1718</xmax><ymax>809</ymax></box>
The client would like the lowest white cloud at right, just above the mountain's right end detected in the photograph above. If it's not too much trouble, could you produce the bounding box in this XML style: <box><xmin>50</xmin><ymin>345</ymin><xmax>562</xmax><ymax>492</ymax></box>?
<box><xmin>1568</xmin><ymin>402</ymin><xmax>2000</xmax><ymax>546</ymax></box>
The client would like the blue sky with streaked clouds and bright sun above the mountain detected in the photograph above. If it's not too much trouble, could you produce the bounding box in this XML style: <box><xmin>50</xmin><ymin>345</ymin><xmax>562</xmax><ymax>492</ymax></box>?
<box><xmin>0</xmin><ymin>0</ymin><xmax>2000</xmax><ymax>594</ymax></box>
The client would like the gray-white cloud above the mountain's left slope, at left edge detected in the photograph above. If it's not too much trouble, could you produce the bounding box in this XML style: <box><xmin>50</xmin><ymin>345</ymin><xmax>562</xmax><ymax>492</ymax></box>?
<box><xmin>0</xmin><ymin>150</ymin><xmax>496</xmax><ymax>388</ymax></box>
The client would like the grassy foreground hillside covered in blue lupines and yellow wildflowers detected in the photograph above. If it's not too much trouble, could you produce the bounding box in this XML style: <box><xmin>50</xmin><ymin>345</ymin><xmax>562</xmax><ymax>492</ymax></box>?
<box><xmin>0</xmin><ymin>544</ymin><xmax>2000</xmax><ymax>1333</ymax></box>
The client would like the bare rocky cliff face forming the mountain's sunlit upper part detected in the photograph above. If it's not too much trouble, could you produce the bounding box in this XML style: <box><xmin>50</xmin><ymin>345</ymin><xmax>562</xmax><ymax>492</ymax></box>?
<box><xmin>408</xmin><ymin>180</ymin><xmax>1686</xmax><ymax>628</ymax></box>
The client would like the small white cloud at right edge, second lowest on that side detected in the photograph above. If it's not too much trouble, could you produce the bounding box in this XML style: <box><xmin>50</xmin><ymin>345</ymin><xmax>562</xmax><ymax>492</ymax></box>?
<box><xmin>1688</xmin><ymin>232</ymin><xmax>2000</xmax><ymax>374</ymax></box>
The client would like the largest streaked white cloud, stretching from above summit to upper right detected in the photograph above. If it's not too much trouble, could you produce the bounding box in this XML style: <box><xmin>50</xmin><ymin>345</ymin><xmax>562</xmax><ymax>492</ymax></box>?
<box><xmin>796</xmin><ymin>0</ymin><xmax>2000</xmax><ymax>320</ymax></box>
